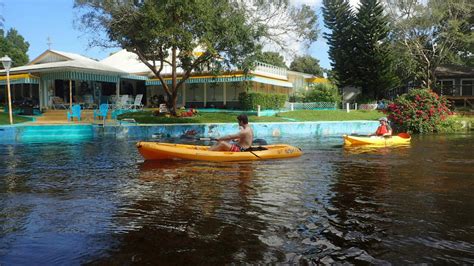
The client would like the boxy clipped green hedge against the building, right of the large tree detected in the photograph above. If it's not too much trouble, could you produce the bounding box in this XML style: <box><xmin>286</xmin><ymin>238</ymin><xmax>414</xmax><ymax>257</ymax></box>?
<box><xmin>239</xmin><ymin>92</ymin><xmax>287</xmax><ymax>110</ymax></box>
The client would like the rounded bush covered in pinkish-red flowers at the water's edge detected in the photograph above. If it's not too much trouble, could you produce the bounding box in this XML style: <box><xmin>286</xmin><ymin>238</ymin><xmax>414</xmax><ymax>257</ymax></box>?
<box><xmin>385</xmin><ymin>89</ymin><xmax>452</xmax><ymax>134</ymax></box>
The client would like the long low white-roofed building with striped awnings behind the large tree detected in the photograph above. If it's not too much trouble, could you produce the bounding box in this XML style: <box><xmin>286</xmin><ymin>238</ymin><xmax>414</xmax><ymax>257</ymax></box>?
<box><xmin>0</xmin><ymin>50</ymin><xmax>322</xmax><ymax>110</ymax></box>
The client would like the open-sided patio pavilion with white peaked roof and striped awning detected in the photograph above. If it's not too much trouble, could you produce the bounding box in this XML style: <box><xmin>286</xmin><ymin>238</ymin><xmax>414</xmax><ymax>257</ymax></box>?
<box><xmin>0</xmin><ymin>50</ymin><xmax>146</xmax><ymax>109</ymax></box>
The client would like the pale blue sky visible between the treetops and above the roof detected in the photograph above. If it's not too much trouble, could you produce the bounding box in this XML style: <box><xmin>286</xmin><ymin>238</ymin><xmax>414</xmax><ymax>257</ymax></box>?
<box><xmin>0</xmin><ymin>0</ymin><xmax>358</xmax><ymax>68</ymax></box>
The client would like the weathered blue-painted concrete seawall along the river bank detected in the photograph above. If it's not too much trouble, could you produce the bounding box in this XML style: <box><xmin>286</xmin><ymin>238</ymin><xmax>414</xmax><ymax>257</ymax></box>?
<box><xmin>0</xmin><ymin>120</ymin><xmax>378</xmax><ymax>142</ymax></box>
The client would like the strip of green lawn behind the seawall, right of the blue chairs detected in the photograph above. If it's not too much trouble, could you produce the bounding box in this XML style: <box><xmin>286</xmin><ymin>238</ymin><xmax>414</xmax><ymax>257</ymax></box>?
<box><xmin>119</xmin><ymin>110</ymin><xmax>383</xmax><ymax>124</ymax></box>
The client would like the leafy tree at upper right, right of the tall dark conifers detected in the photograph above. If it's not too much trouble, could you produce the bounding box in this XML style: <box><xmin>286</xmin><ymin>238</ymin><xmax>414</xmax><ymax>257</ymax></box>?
<box><xmin>385</xmin><ymin>0</ymin><xmax>474</xmax><ymax>88</ymax></box>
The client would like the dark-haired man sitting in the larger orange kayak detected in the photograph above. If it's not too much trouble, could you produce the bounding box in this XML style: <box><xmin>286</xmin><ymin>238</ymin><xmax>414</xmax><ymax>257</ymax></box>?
<box><xmin>209</xmin><ymin>114</ymin><xmax>253</xmax><ymax>152</ymax></box>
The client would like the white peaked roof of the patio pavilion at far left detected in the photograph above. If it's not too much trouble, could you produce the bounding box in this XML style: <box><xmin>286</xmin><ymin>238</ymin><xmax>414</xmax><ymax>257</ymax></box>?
<box><xmin>0</xmin><ymin>50</ymin><xmax>127</xmax><ymax>75</ymax></box>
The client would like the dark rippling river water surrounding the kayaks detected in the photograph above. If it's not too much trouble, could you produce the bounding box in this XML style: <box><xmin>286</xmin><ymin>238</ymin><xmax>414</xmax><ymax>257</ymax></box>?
<box><xmin>0</xmin><ymin>134</ymin><xmax>474</xmax><ymax>265</ymax></box>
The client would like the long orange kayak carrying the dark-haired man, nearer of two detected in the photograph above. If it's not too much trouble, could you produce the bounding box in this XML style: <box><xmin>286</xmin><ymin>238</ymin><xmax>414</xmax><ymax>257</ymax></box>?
<box><xmin>137</xmin><ymin>141</ymin><xmax>303</xmax><ymax>162</ymax></box>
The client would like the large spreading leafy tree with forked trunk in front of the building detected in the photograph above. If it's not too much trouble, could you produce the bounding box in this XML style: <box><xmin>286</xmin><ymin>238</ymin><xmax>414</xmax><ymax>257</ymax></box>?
<box><xmin>75</xmin><ymin>0</ymin><xmax>317</xmax><ymax>113</ymax></box>
